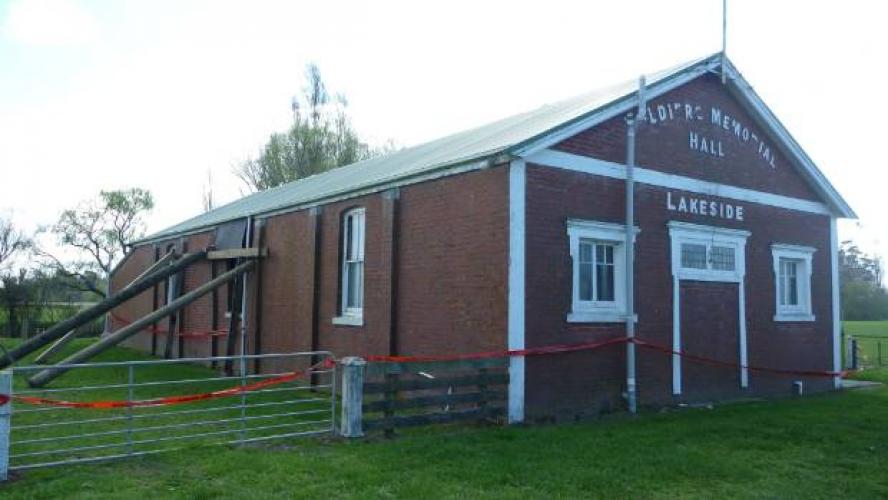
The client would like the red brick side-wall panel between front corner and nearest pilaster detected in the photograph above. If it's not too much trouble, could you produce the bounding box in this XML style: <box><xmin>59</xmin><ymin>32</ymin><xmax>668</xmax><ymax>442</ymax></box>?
<box><xmin>398</xmin><ymin>166</ymin><xmax>509</xmax><ymax>354</ymax></box>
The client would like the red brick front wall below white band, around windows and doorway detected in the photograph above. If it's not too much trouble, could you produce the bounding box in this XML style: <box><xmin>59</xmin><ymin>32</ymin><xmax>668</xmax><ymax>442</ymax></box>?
<box><xmin>526</xmin><ymin>165</ymin><xmax>832</xmax><ymax>417</ymax></box>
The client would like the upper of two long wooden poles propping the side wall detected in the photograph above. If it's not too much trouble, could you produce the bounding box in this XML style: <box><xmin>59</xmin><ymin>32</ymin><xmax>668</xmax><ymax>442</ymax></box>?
<box><xmin>0</xmin><ymin>251</ymin><xmax>207</xmax><ymax>369</ymax></box>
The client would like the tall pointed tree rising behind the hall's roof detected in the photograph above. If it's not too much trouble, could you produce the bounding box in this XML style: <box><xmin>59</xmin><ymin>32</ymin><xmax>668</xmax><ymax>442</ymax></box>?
<box><xmin>235</xmin><ymin>64</ymin><xmax>376</xmax><ymax>191</ymax></box>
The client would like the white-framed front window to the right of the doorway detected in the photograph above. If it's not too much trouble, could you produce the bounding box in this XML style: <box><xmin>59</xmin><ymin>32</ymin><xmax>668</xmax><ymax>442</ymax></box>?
<box><xmin>771</xmin><ymin>243</ymin><xmax>816</xmax><ymax>321</ymax></box>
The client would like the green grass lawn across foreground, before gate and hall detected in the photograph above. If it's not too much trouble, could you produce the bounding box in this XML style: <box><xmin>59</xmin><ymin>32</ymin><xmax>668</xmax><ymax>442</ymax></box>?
<box><xmin>0</xmin><ymin>332</ymin><xmax>888</xmax><ymax>499</ymax></box>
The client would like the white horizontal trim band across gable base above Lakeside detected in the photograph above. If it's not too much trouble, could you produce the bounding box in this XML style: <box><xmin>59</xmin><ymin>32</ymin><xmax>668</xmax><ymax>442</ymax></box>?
<box><xmin>527</xmin><ymin>149</ymin><xmax>832</xmax><ymax>215</ymax></box>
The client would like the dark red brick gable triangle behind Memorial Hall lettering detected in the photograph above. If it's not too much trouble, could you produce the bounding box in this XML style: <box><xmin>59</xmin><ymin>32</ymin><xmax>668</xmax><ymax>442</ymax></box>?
<box><xmin>554</xmin><ymin>74</ymin><xmax>817</xmax><ymax>200</ymax></box>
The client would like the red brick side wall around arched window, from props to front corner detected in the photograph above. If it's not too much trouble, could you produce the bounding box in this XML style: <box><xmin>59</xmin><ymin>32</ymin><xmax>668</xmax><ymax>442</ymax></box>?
<box><xmin>250</xmin><ymin>167</ymin><xmax>508</xmax><ymax>372</ymax></box>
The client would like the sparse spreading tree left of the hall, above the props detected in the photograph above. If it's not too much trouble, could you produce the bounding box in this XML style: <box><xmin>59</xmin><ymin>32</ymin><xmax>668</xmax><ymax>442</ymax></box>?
<box><xmin>36</xmin><ymin>188</ymin><xmax>154</xmax><ymax>297</ymax></box>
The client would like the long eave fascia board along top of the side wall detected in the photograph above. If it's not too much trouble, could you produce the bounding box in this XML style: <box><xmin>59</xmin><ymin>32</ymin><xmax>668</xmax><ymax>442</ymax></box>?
<box><xmin>139</xmin><ymin>154</ymin><xmax>511</xmax><ymax>247</ymax></box>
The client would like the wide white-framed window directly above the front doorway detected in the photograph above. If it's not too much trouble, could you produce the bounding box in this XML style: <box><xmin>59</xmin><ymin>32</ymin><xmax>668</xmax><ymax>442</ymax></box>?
<box><xmin>669</xmin><ymin>221</ymin><xmax>750</xmax><ymax>282</ymax></box>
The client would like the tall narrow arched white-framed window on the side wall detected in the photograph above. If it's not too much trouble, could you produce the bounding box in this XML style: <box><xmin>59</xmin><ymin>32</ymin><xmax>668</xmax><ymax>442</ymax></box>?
<box><xmin>333</xmin><ymin>208</ymin><xmax>366</xmax><ymax>325</ymax></box>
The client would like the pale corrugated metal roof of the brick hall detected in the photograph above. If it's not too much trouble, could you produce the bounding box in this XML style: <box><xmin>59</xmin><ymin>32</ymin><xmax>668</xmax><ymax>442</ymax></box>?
<box><xmin>142</xmin><ymin>54</ymin><xmax>719</xmax><ymax>242</ymax></box>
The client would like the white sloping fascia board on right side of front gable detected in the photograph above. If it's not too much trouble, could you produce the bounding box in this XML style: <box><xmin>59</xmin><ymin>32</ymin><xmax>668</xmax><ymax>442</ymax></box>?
<box><xmin>725</xmin><ymin>59</ymin><xmax>857</xmax><ymax>219</ymax></box>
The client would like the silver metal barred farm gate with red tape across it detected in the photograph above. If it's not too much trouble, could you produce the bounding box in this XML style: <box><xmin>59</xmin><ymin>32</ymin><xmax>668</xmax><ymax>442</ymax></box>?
<box><xmin>9</xmin><ymin>352</ymin><xmax>336</xmax><ymax>470</ymax></box>
